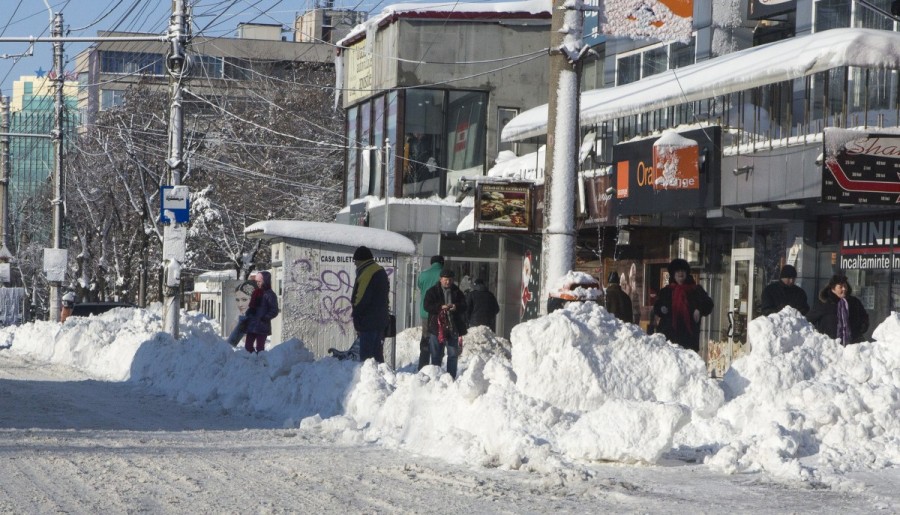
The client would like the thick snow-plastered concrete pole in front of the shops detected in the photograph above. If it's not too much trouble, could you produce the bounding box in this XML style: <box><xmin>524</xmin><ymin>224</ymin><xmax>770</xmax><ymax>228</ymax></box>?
<box><xmin>540</xmin><ymin>0</ymin><xmax>587</xmax><ymax>314</ymax></box>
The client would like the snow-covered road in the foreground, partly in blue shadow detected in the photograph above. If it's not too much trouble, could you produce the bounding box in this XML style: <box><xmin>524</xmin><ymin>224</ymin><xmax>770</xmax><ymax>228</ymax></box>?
<box><xmin>0</xmin><ymin>350</ymin><xmax>900</xmax><ymax>513</ymax></box>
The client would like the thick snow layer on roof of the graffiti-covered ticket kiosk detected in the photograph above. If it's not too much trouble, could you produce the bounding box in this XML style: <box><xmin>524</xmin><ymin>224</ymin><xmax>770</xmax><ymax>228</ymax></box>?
<box><xmin>244</xmin><ymin>220</ymin><xmax>416</xmax><ymax>254</ymax></box>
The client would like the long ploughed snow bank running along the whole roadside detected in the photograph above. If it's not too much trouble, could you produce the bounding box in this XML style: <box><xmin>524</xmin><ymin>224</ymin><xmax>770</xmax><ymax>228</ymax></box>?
<box><xmin>0</xmin><ymin>302</ymin><xmax>900</xmax><ymax>486</ymax></box>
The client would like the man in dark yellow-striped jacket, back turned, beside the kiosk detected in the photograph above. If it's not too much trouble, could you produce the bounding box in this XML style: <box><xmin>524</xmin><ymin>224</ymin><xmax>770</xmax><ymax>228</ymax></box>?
<box><xmin>350</xmin><ymin>246</ymin><xmax>390</xmax><ymax>363</ymax></box>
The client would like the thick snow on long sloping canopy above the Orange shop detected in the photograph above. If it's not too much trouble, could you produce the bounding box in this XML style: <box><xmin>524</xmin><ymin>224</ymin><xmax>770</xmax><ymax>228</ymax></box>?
<box><xmin>502</xmin><ymin>29</ymin><xmax>900</xmax><ymax>141</ymax></box>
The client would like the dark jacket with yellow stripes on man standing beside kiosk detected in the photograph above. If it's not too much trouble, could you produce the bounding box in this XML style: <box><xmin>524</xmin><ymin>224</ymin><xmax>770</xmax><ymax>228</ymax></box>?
<box><xmin>350</xmin><ymin>259</ymin><xmax>390</xmax><ymax>333</ymax></box>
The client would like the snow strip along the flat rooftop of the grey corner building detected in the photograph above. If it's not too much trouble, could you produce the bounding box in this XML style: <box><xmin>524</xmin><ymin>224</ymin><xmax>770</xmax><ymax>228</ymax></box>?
<box><xmin>337</xmin><ymin>0</ymin><xmax>550</xmax><ymax>47</ymax></box>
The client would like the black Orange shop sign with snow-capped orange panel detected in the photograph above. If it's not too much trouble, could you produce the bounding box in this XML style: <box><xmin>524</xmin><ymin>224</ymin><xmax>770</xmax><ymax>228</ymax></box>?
<box><xmin>613</xmin><ymin>127</ymin><xmax>721</xmax><ymax>219</ymax></box>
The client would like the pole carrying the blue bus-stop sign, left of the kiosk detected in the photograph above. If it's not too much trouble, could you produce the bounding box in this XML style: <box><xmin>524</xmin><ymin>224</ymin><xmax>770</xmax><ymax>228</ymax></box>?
<box><xmin>161</xmin><ymin>0</ymin><xmax>189</xmax><ymax>338</ymax></box>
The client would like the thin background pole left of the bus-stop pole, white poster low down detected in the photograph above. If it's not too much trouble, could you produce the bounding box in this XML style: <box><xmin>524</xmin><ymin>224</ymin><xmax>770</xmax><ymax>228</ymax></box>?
<box><xmin>49</xmin><ymin>13</ymin><xmax>66</xmax><ymax>322</ymax></box>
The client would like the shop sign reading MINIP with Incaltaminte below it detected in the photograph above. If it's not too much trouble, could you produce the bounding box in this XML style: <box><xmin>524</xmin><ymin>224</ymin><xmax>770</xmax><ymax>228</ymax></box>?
<box><xmin>841</xmin><ymin>216</ymin><xmax>900</xmax><ymax>270</ymax></box>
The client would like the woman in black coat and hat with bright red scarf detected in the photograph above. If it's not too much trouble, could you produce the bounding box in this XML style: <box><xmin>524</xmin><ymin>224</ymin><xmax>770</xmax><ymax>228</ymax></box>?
<box><xmin>653</xmin><ymin>259</ymin><xmax>713</xmax><ymax>354</ymax></box>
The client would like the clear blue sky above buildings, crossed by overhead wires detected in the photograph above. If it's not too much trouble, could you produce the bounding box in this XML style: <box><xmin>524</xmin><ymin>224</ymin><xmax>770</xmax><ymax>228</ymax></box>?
<box><xmin>0</xmin><ymin>0</ymin><xmax>352</xmax><ymax>96</ymax></box>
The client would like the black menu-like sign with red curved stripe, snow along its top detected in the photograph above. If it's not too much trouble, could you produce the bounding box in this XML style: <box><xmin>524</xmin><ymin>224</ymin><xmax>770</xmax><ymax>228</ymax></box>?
<box><xmin>822</xmin><ymin>128</ymin><xmax>900</xmax><ymax>206</ymax></box>
